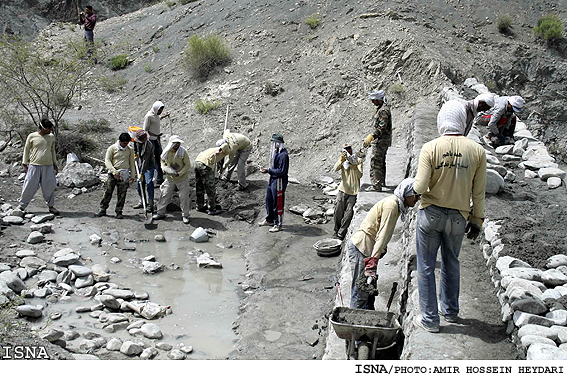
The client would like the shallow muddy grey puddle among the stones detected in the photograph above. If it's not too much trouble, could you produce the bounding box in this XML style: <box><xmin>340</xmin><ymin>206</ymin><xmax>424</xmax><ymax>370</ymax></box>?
<box><xmin>27</xmin><ymin>219</ymin><xmax>247</xmax><ymax>359</ymax></box>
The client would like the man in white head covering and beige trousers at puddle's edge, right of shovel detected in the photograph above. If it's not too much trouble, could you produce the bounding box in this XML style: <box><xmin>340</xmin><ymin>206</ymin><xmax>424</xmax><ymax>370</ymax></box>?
<box><xmin>153</xmin><ymin>135</ymin><xmax>191</xmax><ymax>224</ymax></box>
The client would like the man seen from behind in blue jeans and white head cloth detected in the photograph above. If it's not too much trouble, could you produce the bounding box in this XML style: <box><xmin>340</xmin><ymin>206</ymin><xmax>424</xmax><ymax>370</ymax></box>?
<box><xmin>413</xmin><ymin>100</ymin><xmax>486</xmax><ymax>333</ymax></box>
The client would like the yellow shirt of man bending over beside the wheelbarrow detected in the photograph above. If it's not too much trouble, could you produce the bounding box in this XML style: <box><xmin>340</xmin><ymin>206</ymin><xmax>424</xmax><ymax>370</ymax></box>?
<box><xmin>350</xmin><ymin>195</ymin><xmax>400</xmax><ymax>257</ymax></box>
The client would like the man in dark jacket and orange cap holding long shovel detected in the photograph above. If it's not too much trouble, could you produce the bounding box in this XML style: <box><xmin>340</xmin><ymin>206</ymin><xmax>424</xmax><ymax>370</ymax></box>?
<box><xmin>133</xmin><ymin>129</ymin><xmax>156</xmax><ymax>213</ymax></box>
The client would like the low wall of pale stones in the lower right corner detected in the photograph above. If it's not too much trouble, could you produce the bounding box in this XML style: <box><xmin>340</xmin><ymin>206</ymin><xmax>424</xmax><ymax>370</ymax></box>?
<box><xmin>483</xmin><ymin>221</ymin><xmax>567</xmax><ymax>360</ymax></box>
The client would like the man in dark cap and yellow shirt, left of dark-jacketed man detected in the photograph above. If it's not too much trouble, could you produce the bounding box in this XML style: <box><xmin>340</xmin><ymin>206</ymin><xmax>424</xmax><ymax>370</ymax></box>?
<box><xmin>95</xmin><ymin>133</ymin><xmax>136</xmax><ymax>219</ymax></box>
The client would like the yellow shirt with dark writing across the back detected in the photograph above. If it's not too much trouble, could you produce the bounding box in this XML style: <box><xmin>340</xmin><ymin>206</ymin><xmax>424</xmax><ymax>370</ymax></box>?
<box><xmin>413</xmin><ymin>136</ymin><xmax>486</xmax><ymax>225</ymax></box>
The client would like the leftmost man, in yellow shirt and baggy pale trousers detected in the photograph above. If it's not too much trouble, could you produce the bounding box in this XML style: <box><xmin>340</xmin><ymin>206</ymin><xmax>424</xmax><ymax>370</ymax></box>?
<box><xmin>18</xmin><ymin>119</ymin><xmax>59</xmax><ymax>215</ymax></box>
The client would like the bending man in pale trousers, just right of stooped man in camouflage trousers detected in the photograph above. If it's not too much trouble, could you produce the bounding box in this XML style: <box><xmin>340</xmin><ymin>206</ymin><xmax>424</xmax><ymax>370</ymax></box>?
<box><xmin>219</xmin><ymin>129</ymin><xmax>252</xmax><ymax>190</ymax></box>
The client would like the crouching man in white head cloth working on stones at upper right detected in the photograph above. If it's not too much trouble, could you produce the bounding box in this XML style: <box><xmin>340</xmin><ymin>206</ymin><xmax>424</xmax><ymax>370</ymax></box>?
<box><xmin>477</xmin><ymin>95</ymin><xmax>525</xmax><ymax>147</ymax></box>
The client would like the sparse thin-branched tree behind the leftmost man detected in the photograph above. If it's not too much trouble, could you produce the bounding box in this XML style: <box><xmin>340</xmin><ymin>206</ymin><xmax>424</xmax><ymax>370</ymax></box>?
<box><xmin>0</xmin><ymin>37</ymin><xmax>92</xmax><ymax>137</ymax></box>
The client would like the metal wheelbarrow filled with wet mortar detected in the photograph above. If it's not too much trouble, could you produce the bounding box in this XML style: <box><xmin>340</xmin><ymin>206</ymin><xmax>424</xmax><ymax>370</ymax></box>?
<box><xmin>330</xmin><ymin>307</ymin><xmax>403</xmax><ymax>360</ymax></box>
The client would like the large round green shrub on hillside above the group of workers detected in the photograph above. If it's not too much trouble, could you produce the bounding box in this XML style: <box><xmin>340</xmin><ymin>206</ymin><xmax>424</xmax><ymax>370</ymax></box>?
<box><xmin>183</xmin><ymin>34</ymin><xmax>230</xmax><ymax>77</ymax></box>
